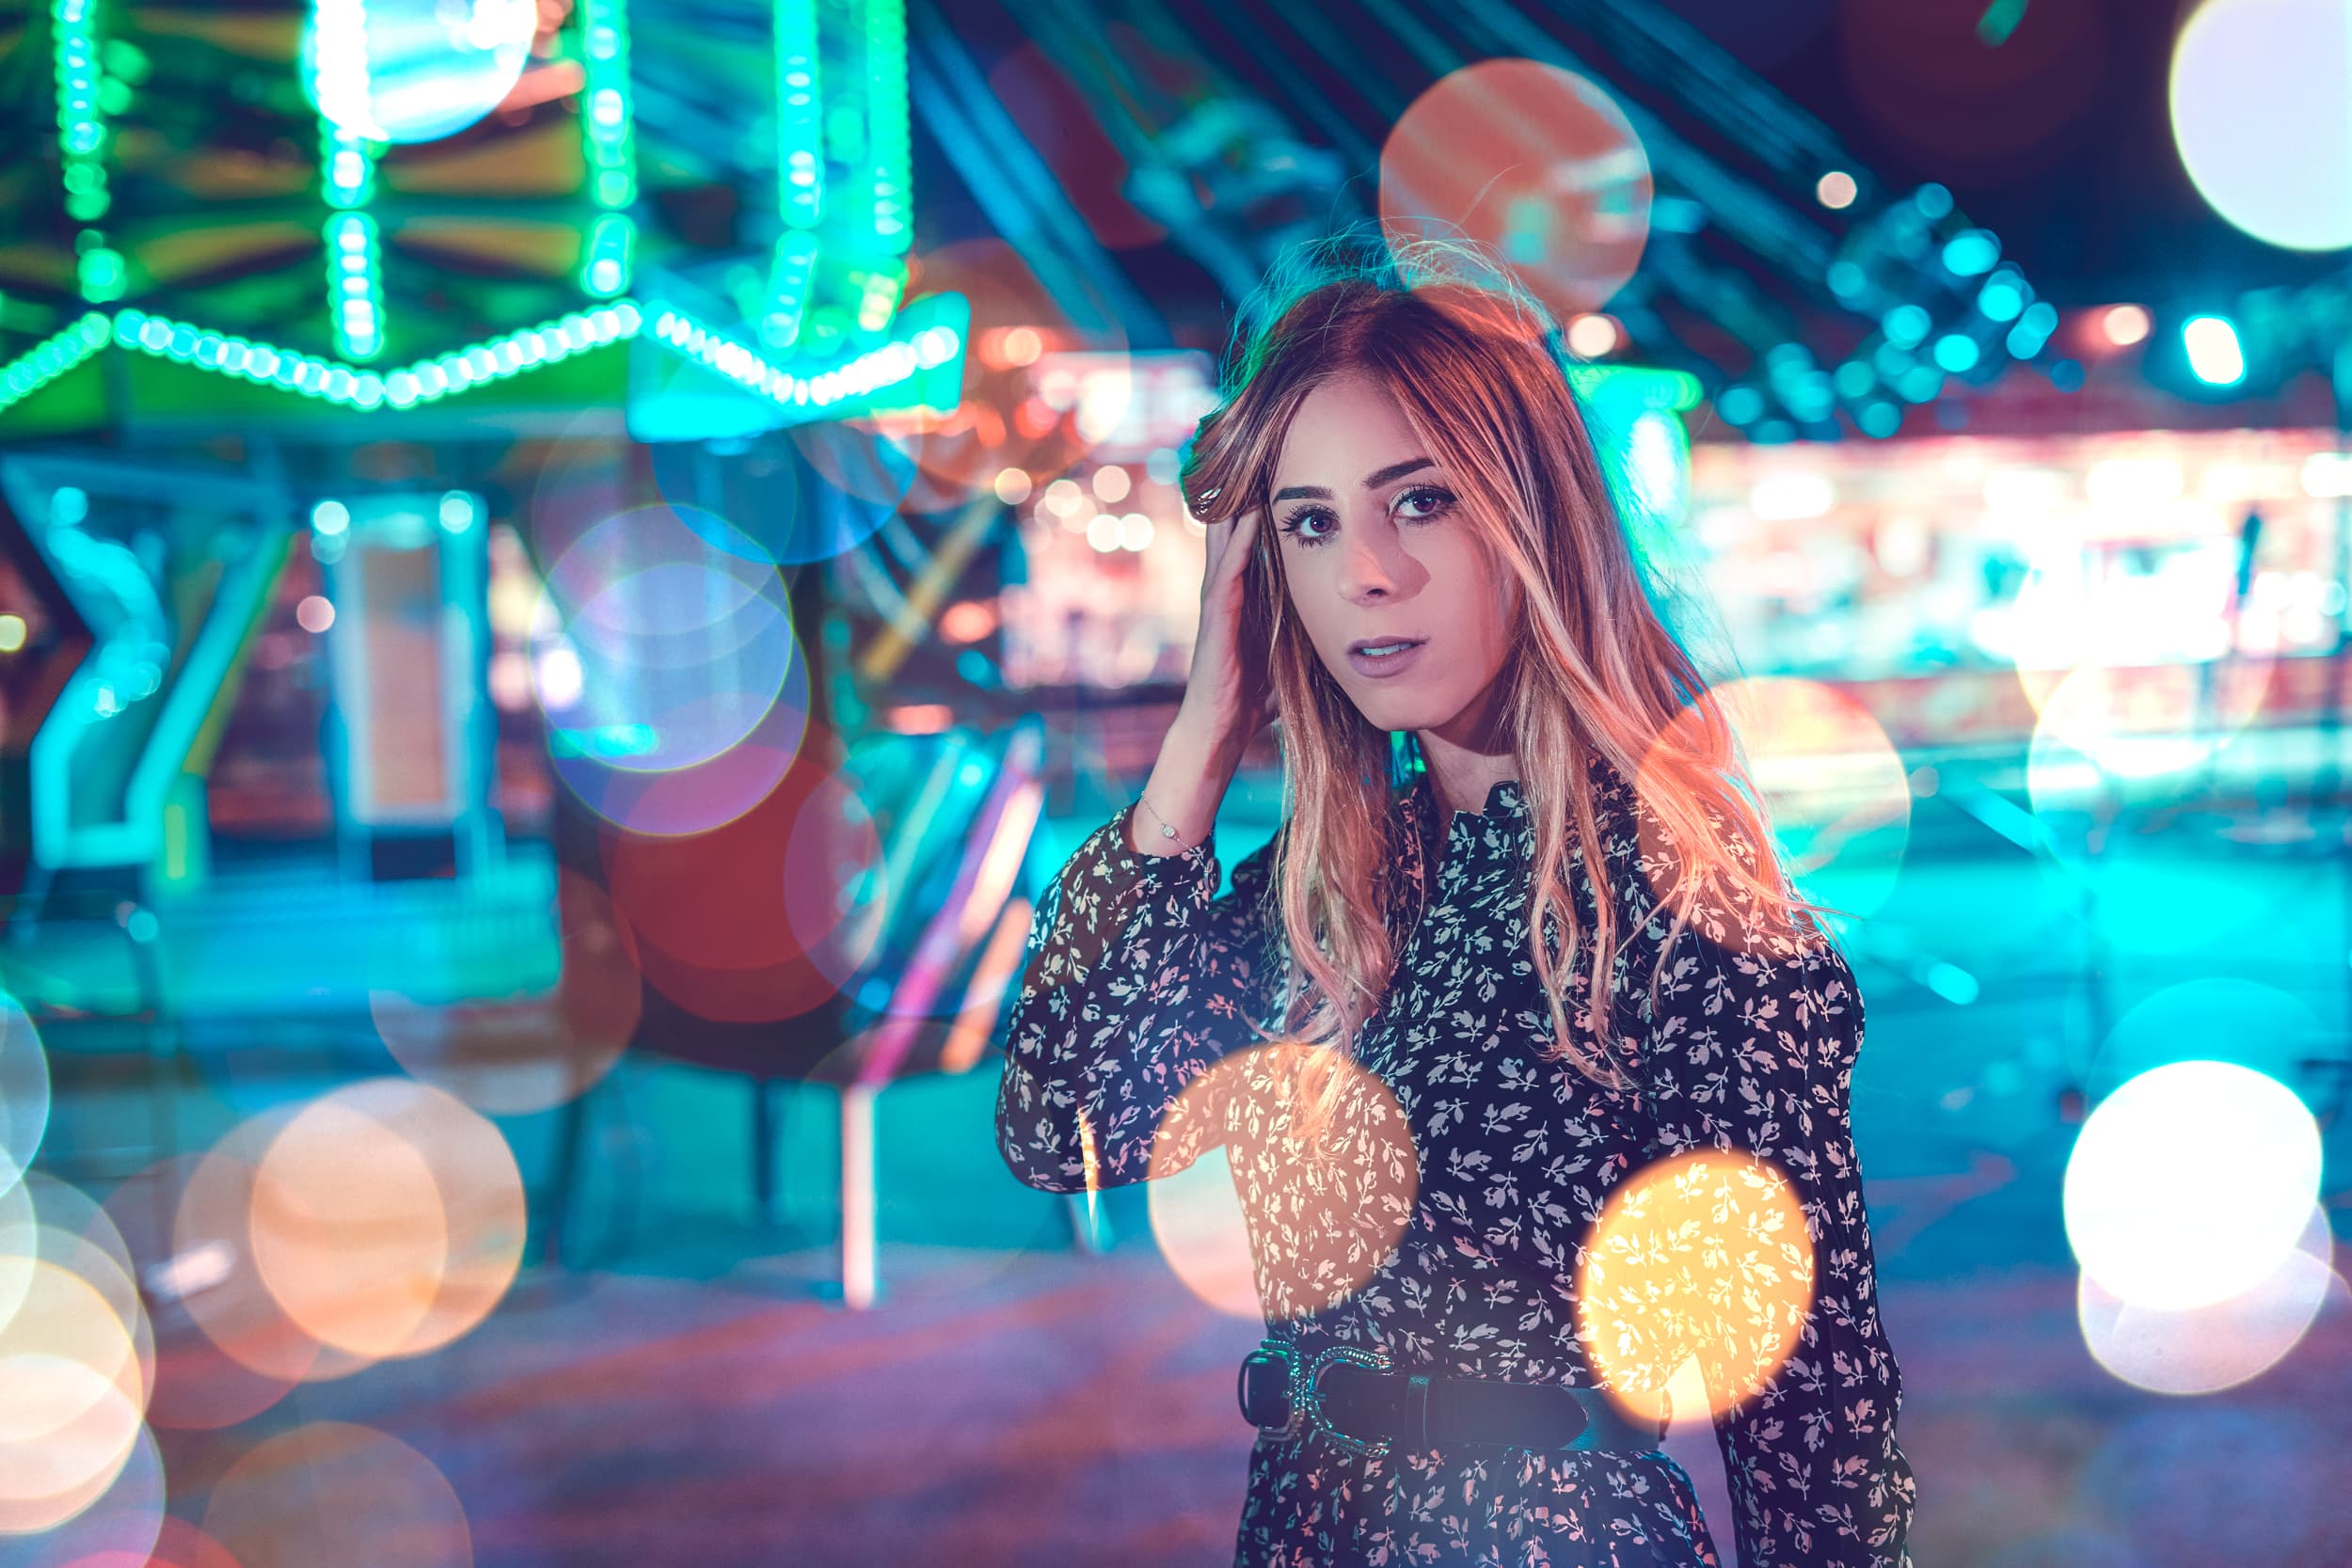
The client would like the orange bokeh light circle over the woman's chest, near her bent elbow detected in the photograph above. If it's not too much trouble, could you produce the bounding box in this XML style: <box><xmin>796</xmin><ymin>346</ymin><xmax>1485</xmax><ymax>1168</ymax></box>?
<box><xmin>1148</xmin><ymin>1041</ymin><xmax>1421</xmax><ymax>1319</ymax></box>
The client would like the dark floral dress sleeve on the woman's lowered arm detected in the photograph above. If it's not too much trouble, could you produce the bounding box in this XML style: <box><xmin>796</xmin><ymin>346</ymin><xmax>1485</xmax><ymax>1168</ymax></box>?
<box><xmin>1626</xmin><ymin>818</ymin><xmax>1917</xmax><ymax>1568</ymax></box>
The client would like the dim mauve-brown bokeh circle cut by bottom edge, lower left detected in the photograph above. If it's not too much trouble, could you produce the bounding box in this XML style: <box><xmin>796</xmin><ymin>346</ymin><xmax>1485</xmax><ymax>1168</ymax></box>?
<box><xmin>205</xmin><ymin>1422</ymin><xmax>473</xmax><ymax>1568</ymax></box>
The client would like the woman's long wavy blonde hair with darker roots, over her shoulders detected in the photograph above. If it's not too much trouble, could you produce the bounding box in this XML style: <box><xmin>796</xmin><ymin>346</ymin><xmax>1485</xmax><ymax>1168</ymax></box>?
<box><xmin>1181</xmin><ymin>235</ymin><xmax>1833</xmax><ymax>1114</ymax></box>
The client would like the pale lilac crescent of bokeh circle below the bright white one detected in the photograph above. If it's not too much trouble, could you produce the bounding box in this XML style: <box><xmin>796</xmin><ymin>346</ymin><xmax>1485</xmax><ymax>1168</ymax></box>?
<box><xmin>2074</xmin><ymin>1206</ymin><xmax>2347</xmax><ymax>1394</ymax></box>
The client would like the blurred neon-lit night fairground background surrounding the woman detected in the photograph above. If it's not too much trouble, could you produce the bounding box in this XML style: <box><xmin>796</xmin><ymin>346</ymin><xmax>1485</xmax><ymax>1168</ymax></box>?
<box><xmin>0</xmin><ymin>0</ymin><xmax>2352</xmax><ymax>1568</ymax></box>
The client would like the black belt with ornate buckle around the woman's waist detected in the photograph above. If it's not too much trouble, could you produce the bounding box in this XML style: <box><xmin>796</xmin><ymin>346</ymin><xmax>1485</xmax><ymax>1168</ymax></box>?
<box><xmin>1242</xmin><ymin>1340</ymin><xmax>1665</xmax><ymax>1458</ymax></box>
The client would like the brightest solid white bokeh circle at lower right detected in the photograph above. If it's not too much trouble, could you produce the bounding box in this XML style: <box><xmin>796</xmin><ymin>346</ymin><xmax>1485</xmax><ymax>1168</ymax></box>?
<box><xmin>2065</xmin><ymin>1060</ymin><xmax>2319</xmax><ymax>1312</ymax></box>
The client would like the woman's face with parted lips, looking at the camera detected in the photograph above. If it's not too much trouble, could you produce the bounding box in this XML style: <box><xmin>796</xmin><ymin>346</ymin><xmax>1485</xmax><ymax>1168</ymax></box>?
<box><xmin>1268</xmin><ymin>373</ymin><xmax>1518</xmax><ymax>745</ymax></box>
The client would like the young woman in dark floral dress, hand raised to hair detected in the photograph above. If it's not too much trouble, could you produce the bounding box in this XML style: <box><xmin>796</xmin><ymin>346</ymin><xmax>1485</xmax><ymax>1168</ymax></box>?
<box><xmin>997</xmin><ymin>236</ymin><xmax>1915</xmax><ymax>1568</ymax></box>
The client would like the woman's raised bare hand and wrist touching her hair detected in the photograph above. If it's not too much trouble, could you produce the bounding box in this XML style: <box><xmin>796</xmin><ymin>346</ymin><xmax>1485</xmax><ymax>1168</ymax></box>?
<box><xmin>1129</xmin><ymin>513</ymin><xmax>1268</xmax><ymax>853</ymax></box>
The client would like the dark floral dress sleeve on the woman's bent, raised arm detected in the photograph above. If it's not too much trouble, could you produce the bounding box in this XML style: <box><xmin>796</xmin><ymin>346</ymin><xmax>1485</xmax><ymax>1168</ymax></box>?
<box><xmin>997</xmin><ymin>804</ymin><xmax>1279</xmax><ymax>1192</ymax></box>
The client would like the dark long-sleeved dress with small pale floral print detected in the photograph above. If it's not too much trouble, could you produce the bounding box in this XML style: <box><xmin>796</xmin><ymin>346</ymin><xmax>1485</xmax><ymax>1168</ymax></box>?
<box><xmin>997</xmin><ymin>762</ymin><xmax>1917</xmax><ymax>1568</ymax></box>
